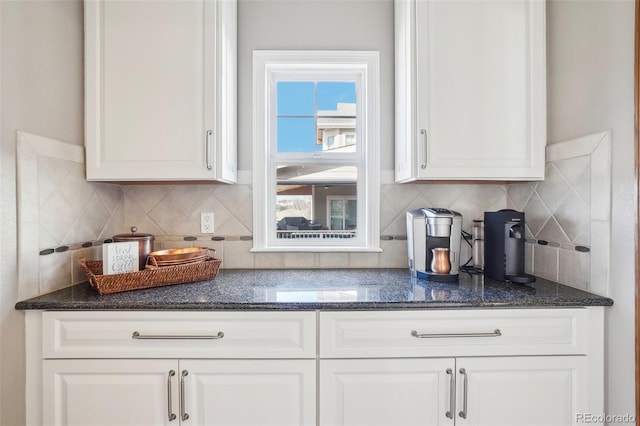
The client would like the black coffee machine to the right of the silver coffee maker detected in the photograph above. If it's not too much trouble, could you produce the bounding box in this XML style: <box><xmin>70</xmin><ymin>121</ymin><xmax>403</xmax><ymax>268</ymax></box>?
<box><xmin>484</xmin><ymin>209</ymin><xmax>536</xmax><ymax>284</ymax></box>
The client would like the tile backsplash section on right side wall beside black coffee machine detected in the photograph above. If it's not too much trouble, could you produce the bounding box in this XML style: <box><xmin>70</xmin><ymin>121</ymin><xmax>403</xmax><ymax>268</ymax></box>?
<box><xmin>507</xmin><ymin>131</ymin><xmax>611</xmax><ymax>295</ymax></box>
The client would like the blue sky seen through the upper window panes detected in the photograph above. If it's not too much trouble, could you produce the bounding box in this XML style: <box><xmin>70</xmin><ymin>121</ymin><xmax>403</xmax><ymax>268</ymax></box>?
<box><xmin>276</xmin><ymin>81</ymin><xmax>356</xmax><ymax>152</ymax></box>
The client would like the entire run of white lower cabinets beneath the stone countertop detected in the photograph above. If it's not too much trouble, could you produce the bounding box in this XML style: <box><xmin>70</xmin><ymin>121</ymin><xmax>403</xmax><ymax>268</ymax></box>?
<box><xmin>26</xmin><ymin>307</ymin><xmax>605</xmax><ymax>426</ymax></box>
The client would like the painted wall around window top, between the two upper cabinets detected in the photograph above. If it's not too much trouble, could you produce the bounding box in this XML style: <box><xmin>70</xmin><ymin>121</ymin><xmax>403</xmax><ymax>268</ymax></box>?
<box><xmin>238</xmin><ymin>0</ymin><xmax>394</xmax><ymax>171</ymax></box>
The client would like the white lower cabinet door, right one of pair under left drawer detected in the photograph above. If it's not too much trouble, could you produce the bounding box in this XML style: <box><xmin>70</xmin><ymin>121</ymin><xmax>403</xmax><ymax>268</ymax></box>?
<box><xmin>180</xmin><ymin>360</ymin><xmax>316</xmax><ymax>426</ymax></box>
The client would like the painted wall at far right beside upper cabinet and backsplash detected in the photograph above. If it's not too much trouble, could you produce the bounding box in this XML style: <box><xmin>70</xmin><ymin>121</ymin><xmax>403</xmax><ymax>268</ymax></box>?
<box><xmin>547</xmin><ymin>0</ymin><xmax>636</xmax><ymax>415</ymax></box>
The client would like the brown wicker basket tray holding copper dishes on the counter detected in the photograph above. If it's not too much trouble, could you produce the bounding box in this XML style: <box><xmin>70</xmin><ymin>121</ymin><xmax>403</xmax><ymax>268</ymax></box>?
<box><xmin>80</xmin><ymin>257</ymin><xmax>221</xmax><ymax>294</ymax></box>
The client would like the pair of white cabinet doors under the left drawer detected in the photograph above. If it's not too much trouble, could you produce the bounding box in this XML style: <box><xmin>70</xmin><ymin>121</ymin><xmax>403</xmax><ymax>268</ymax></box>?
<box><xmin>43</xmin><ymin>359</ymin><xmax>316</xmax><ymax>426</ymax></box>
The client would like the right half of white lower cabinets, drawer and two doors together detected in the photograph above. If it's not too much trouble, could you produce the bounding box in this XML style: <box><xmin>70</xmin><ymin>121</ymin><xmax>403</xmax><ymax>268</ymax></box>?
<box><xmin>318</xmin><ymin>308</ymin><xmax>604</xmax><ymax>426</ymax></box>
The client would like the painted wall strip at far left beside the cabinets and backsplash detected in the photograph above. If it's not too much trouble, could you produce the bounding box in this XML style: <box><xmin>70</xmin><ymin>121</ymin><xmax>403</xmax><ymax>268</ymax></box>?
<box><xmin>0</xmin><ymin>0</ymin><xmax>83</xmax><ymax>426</ymax></box>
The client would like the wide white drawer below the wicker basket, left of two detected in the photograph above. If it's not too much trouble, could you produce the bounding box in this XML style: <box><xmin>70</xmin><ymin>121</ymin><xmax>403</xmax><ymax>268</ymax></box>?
<box><xmin>42</xmin><ymin>311</ymin><xmax>316</xmax><ymax>358</ymax></box>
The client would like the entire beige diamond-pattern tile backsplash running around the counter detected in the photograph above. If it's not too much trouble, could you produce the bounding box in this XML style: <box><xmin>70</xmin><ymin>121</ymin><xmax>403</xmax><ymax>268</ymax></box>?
<box><xmin>18</xmin><ymin>132</ymin><xmax>606</xmax><ymax>298</ymax></box>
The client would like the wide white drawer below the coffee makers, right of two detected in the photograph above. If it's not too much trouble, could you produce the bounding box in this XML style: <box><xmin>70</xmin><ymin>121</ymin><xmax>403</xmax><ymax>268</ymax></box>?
<box><xmin>319</xmin><ymin>308</ymin><xmax>589</xmax><ymax>358</ymax></box>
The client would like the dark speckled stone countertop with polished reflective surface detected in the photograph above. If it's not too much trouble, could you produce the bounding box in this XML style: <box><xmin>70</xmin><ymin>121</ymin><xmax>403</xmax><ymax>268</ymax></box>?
<box><xmin>16</xmin><ymin>269</ymin><xmax>613</xmax><ymax>310</ymax></box>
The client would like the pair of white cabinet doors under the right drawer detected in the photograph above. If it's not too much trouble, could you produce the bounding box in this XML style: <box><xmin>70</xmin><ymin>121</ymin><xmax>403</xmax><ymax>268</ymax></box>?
<box><xmin>320</xmin><ymin>356</ymin><xmax>588</xmax><ymax>426</ymax></box>
